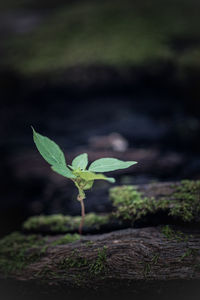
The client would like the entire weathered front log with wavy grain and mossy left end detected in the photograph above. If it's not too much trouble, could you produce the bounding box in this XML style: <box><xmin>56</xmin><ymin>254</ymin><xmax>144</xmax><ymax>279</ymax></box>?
<box><xmin>0</xmin><ymin>226</ymin><xmax>200</xmax><ymax>289</ymax></box>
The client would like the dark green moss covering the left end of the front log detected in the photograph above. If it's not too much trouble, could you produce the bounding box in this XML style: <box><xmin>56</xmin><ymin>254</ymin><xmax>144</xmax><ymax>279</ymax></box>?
<box><xmin>0</xmin><ymin>232</ymin><xmax>46</xmax><ymax>275</ymax></box>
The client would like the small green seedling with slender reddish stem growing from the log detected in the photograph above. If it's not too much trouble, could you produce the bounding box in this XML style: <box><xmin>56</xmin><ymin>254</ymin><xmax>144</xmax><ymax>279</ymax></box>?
<box><xmin>32</xmin><ymin>127</ymin><xmax>137</xmax><ymax>234</ymax></box>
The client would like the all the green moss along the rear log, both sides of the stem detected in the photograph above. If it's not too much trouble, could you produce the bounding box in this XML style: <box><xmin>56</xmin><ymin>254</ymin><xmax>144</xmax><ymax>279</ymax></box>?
<box><xmin>23</xmin><ymin>180</ymin><xmax>200</xmax><ymax>233</ymax></box>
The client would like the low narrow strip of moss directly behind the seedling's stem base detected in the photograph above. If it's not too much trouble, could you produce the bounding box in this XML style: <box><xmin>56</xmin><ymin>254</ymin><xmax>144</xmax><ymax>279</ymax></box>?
<box><xmin>23</xmin><ymin>213</ymin><xmax>109</xmax><ymax>233</ymax></box>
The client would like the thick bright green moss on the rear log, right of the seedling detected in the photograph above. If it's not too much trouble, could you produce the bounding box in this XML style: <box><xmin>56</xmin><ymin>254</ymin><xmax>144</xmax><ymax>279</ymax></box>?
<box><xmin>110</xmin><ymin>180</ymin><xmax>200</xmax><ymax>222</ymax></box>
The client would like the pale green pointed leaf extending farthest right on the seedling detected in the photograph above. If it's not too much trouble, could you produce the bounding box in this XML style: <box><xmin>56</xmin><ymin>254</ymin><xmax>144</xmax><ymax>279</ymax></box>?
<box><xmin>89</xmin><ymin>158</ymin><xmax>137</xmax><ymax>172</ymax></box>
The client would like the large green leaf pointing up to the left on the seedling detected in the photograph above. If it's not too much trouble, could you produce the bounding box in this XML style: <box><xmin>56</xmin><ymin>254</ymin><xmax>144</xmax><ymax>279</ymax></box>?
<box><xmin>32</xmin><ymin>127</ymin><xmax>66</xmax><ymax>166</ymax></box>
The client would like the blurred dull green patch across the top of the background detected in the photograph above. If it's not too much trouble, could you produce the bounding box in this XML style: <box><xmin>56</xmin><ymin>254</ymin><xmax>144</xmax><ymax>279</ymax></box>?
<box><xmin>4</xmin><ymin>0</ymin><xmax>200</xmax><ymax>74</ymax></box>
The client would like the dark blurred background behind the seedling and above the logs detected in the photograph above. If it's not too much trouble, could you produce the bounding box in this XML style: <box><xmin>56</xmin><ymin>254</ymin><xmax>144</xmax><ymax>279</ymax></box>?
<box><xmin>0</xmin><ymin>0</ymin><xmax>200</xmax><ymax>236</ymax></box>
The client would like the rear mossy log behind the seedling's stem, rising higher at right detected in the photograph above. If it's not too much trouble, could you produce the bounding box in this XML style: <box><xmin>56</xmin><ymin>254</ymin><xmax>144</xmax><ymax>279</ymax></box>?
<box><xmin>23</xmin><ymin>180</ymin><xmax>200</xmax><ymax>234</ymax></box>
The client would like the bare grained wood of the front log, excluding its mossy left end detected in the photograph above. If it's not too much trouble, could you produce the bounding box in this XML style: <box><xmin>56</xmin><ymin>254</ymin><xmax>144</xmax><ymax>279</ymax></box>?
<box><xmin>1</xmin><ymin>227</ymin><xmax>200</xmax><ymax>288</ymax></box>
